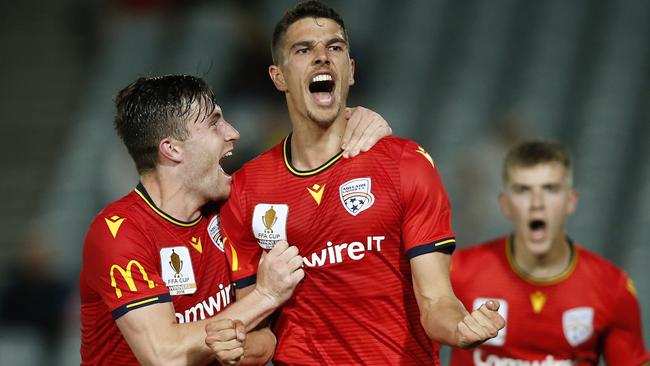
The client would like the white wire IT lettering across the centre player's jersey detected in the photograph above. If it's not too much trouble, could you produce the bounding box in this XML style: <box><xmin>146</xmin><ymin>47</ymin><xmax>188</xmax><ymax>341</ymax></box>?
<box><xmin>302</xmin><ymin>236</ymin><xmax>386</xmax><ymax>267</ymax></box>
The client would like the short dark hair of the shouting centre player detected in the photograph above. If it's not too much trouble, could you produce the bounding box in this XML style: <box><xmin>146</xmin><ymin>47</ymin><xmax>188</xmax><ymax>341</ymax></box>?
<box><xmin>271</xmin><ymin>0</ymin><xmax>348</xmax><ymax>65</ymax></box>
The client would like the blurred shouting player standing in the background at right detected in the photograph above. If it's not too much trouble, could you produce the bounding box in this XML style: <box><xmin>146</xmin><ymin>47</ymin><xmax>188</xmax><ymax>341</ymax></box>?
<box><xmin>451</xmin><ymin>141</ymin><xmax>648</xmax><ymax>366</ymax></box>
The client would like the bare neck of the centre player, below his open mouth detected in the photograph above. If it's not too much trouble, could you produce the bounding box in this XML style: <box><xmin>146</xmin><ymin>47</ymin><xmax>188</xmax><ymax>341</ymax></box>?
<box><xmin>291</xmin><ymin>110</ymin><xmax>347</xmax><ymax>170</ymax></box>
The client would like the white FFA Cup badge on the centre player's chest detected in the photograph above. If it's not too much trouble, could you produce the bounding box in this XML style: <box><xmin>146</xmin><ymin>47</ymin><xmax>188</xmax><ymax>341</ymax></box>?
<box><xmin>253</xmin><ymin>203</ymin><xmax>289</xmax><ymax>249</ymax></box>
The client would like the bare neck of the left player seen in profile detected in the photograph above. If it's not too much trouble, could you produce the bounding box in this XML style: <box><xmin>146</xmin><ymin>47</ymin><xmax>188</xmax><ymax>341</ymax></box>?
<box><xmin>140</xmin><ymin>169</ymin><xmax>205</xmax><ymax>221</ymax></box>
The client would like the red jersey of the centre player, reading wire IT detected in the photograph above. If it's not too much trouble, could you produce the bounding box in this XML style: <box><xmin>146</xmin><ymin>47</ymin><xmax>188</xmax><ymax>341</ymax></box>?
<box><xmin>221</xmin><ymin>136</ymin><xmax>455</xmax><ymax>365</ymax></box>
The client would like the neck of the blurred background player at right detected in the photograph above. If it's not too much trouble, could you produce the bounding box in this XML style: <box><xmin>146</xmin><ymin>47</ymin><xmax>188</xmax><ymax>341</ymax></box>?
<box><xmin>512</xmin><ymin>235</ymin><xmax>572</xmax><ymax>280</ymax></box>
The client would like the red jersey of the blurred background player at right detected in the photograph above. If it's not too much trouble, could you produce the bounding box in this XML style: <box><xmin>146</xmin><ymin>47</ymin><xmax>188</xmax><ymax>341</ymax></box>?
<box><xmin>451</xmin><ymin>238</ymin><xmax>648</xmax><ymax>366</ymax></box>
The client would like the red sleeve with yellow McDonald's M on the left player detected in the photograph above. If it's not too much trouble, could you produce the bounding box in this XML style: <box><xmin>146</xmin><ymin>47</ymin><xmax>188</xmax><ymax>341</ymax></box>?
<box><xmin>83</xmin><ymin>213</ymin><xmax>171</xmax><ymax>319</ymax></box>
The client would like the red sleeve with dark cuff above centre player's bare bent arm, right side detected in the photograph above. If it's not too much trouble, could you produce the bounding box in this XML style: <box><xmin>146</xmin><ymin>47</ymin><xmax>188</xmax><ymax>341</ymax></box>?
<box><xmin>400</xmin><ymin>142</ymin><xmax>456</xmax><ymax>259</ymax></box>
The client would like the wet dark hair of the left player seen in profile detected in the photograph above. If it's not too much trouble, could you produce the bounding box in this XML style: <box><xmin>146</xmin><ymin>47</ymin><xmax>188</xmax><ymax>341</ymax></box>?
<box><xmin>114</xmin><ymin>75</ymin><xmax>216</xmax><ymax>174</ymax></box>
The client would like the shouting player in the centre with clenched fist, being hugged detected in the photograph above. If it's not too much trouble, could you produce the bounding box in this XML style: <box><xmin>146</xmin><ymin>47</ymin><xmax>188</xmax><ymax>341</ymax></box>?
<box><xmin>213</xmin><ymin>1</ymin><xmax>504</xmax><ymax>365</ymax></box>
